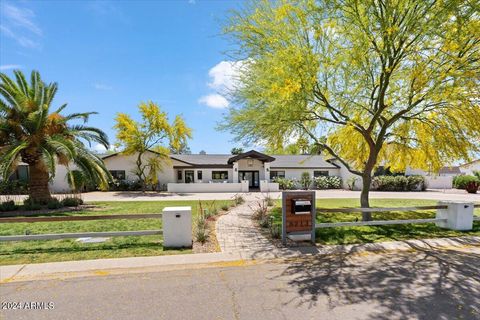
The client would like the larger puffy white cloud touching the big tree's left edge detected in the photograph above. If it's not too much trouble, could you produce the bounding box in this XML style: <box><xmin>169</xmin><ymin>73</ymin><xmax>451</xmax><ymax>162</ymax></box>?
<box><xmin>208</xmin><ymin>61</ymin><xmax>244</xmax><ymax>92</ymax></box>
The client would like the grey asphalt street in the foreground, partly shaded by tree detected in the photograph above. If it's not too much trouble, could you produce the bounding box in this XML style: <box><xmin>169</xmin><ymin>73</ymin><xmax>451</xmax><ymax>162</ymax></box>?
<box><xmin>0</xmin><ymin>245</ymin><xmax>480</xmax><ymax>320</ymax></box>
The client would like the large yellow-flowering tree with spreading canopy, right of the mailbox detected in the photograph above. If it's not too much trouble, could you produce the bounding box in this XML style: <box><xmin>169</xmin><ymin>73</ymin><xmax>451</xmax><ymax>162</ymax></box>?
<box><xmin>220</xmin><ymin>0</ymin><xmax>480</xmax><ymax>220</ymax></box>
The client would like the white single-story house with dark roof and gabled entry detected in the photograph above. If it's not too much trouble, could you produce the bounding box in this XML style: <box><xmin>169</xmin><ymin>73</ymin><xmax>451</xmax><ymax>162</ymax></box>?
<box><xmin>51</xmin><ymin>150</ymin><xmax>350</xmax><ymax>192</ymax></box>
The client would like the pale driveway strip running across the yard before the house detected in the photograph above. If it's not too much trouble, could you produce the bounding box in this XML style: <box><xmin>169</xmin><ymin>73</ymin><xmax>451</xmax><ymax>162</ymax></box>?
<box><xmin>25</xmin><ymin>190</ymin><xmax>480</xmax><ymax>202</ymax></box>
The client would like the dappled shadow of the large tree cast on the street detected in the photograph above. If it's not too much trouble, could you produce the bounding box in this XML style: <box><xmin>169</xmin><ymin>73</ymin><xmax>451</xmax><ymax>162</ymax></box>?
<box><xmin>275</xmin><ymin>238</ymin><xmax>480</xmax><ymax>320</ymax></box>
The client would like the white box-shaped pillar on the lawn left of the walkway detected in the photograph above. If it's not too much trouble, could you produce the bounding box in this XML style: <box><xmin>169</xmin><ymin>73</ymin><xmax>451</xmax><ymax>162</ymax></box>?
<box><xmin>162</xmin><ymin>207</ymin><xmax>192</xmax><ymax>248</ymax></box>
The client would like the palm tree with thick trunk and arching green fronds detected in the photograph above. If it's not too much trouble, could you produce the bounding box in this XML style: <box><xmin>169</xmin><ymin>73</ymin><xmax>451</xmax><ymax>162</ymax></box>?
<box><xmin>0</xmin><ymin>70</ymin><xmax>110</xmax><ymax>203</ymax></box>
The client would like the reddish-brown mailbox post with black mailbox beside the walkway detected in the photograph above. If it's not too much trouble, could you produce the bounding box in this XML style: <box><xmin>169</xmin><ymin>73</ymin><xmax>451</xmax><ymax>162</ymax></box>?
<box><xmin>282</xmin><ymin>191</ymin><xmax>316</xmax><ymax>244</ymax></box>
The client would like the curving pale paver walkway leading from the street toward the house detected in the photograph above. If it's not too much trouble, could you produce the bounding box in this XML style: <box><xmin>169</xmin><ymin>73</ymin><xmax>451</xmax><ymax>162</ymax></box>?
<box><xmin>216</xmin><ymin>195</ymin><xmax>276</xmax><ymax>258</ymax></box>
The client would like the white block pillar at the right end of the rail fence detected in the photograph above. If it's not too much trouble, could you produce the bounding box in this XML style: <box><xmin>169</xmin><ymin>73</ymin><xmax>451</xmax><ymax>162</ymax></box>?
<box><xmin>435</xmin><ymin>201</ymin><xmax>474</xmax><ymax>230</ymax></box>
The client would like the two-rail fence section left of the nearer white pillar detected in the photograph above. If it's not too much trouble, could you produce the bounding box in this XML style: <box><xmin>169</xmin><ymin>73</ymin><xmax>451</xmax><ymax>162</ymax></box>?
<box><xmin>0</xmin><ymin>213</ymin><xmax>163</xmax><ymax>242</ymax></box>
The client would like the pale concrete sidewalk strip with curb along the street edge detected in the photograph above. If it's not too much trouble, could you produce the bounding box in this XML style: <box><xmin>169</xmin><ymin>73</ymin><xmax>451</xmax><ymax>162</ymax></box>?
<box><xmin>0</xmin><ymin>236</ymin><xmax>480</xmax><ymax>283</ymax></box>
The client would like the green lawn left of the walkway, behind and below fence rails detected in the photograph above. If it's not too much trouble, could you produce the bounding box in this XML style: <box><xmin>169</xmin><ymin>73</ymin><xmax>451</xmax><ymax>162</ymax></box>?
<box><xmin>0</xmin><ymin>200</ymin><xmax>232</xmax><ymax>265</ymax></box>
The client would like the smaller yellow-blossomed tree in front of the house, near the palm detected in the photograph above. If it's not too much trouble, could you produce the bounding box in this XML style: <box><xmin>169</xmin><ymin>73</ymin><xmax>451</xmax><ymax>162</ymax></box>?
<box><xmin>114</xmin><ymin>101</ymin><xmax>192</xmax><ymax>191</ymax></box>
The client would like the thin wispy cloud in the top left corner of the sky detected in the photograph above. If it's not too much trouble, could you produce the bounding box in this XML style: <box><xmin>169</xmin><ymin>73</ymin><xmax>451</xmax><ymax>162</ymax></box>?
<box><xmin>0</xmin><ymin>2</ymin><xmax>43</xmax><ymax>48</ymax></box>
